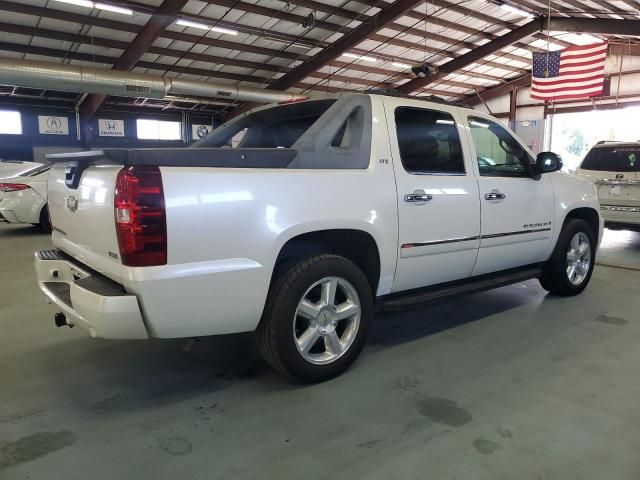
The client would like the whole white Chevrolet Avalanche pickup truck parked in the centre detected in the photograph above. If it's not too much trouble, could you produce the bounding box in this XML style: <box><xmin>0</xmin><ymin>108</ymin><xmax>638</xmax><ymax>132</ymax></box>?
<box><xmin>35</xmin><ymin>93</ymin><xmax>603</xmax><ymax>382</ymax></box>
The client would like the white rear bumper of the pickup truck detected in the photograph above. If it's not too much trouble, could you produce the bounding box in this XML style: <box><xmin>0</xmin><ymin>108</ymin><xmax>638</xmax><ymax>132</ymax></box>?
<box><xmin>35</xmin><ymin>250</ymin><xmax>149</xmax><ymax>339</ymax></box>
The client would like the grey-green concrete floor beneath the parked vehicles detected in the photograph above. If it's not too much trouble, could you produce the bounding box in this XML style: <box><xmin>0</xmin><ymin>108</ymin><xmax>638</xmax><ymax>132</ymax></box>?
<box><xmin>0</xmin><ymin>225</ymin><xmax>640</xmax><ymax>480</ymax></box>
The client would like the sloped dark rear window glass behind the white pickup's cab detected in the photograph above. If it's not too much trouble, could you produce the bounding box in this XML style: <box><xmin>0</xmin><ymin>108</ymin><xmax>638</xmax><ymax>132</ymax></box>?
<box><xmin>191</xmin><ymin>99</ymin><xmax>335</xmax><ymax>148</ymax></box>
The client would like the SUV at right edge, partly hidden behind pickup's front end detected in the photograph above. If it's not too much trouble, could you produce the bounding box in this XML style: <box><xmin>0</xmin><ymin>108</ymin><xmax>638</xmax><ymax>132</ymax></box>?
<box><xmin>576</xmin><ymin>142</ymin><xmax>640</xmax><ymax>229</ymax></box>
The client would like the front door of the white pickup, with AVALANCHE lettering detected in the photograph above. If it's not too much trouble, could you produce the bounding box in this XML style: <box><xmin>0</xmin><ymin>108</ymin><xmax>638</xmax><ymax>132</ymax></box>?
<box><xmin>466</xmin><ymin>115</ymin><xmax>559</xmax><ymax>275</ymax></box>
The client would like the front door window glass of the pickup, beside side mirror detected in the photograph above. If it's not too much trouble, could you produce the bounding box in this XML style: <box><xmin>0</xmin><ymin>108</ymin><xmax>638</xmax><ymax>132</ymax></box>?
<box><xmin>469</xmin><ymin>117</ymin><xmax>532</xmax><ymax>177</ymax></box>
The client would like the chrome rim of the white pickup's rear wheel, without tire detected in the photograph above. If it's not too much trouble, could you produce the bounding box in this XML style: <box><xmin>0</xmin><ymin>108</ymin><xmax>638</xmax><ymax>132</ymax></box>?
<box><xmin>293</xmin><ymin>277</ymin><xmax>362</xmax><ymax>365</ymax></box>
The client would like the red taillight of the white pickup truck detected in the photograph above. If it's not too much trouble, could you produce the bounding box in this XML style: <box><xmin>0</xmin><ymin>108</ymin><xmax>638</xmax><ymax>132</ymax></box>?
<box><xmin>114</xmin><ymin>166</ymin><xmax>167</xmax><ymax>267</ymax></box>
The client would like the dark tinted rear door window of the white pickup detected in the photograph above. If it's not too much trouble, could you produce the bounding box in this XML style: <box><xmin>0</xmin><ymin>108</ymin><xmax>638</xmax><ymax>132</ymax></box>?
<box><xmin>396</xmin><ymin>107</ymin><xmax>465</xmax><ymax>173</ymax></box>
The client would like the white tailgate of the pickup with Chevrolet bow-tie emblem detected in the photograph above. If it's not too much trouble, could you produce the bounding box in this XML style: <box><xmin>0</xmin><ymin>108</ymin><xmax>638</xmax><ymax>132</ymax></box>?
<box><xmin>48</xmin><ymin>163</ymin><xmax>122</xmax><ymax>282</ymax></box>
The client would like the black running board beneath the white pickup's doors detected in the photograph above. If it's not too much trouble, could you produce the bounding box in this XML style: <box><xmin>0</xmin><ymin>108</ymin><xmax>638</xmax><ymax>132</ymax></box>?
<box><xmin>378</xmin><ymin>266</ymin><xmax>542</xmax><ymax>311</ymax></box>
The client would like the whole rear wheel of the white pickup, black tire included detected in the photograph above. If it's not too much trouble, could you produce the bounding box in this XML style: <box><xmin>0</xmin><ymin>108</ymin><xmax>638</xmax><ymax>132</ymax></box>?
<box><xmin>256</xmin><ymin>254</ymin><xmax>373</xmax><ymax>383</ymax></box>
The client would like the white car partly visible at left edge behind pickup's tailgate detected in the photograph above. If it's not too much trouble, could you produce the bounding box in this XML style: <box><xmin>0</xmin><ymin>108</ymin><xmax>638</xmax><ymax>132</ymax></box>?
<box><xmin>0</xmin><ymin>165</ymin><xmax>51</xmax><ymax>232</ymax></box>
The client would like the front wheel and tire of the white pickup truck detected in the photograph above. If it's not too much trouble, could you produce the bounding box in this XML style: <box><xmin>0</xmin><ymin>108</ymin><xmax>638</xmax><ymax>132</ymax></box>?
<box><xmin>540</xmin><ymin>218</ymin><xmax>596</xmax><ymax>297</ymax></box>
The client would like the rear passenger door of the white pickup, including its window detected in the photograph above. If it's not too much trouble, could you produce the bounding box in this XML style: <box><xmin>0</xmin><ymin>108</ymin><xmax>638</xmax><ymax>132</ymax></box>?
<box><xmin>384</xmin><ymin>97</ymin><xmax>480</xmax><ymax>291</ymax></box>
